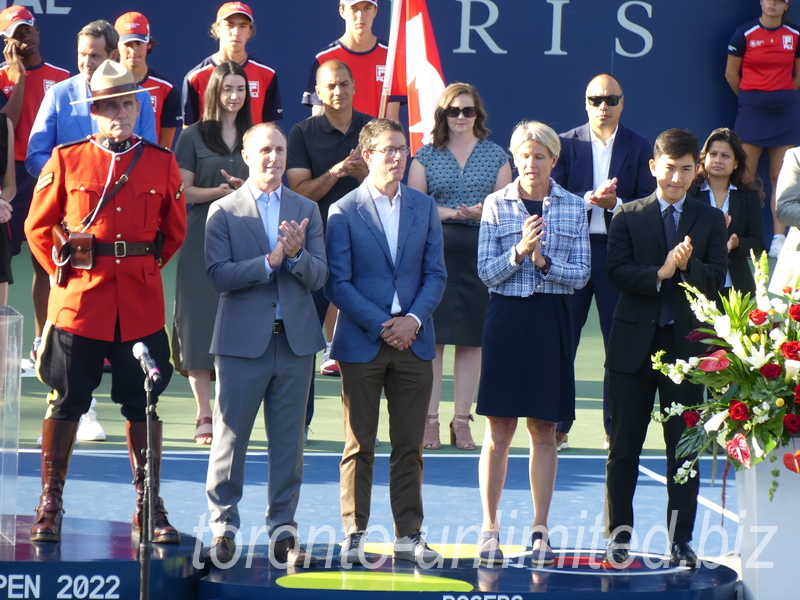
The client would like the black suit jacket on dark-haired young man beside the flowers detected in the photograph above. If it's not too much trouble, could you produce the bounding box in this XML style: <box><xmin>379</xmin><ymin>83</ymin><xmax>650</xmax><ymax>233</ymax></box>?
<box><xmin>606</xmin><ymin>194</ymin><xmax>728</xmax><ymax>373</ymax></box>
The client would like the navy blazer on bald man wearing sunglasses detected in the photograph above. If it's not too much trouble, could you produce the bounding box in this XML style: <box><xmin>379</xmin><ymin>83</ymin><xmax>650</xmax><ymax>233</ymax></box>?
<box><xmin>550</xmin><ymin>123</ymin><xmax>656</xmax><ymax>230</ymax></box>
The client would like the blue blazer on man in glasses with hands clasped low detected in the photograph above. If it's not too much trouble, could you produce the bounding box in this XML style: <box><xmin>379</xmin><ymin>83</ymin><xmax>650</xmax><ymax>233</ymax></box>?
<box><xmin>325</xmin><ymin>181</ymin><xmax>447</xmax><ymax>363</ymax></box>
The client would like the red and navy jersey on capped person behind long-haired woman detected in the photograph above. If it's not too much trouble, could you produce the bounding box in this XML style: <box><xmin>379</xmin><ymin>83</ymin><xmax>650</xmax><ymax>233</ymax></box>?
<box><xmin>182</xmin><ymin>55</ymin><xmax>283</xmax><ymax>125</ymax></box>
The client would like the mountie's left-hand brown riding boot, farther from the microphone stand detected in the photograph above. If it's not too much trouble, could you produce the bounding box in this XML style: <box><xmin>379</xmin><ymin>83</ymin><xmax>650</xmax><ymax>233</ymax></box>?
<box><xmin>30</xmin><ymin>419</ymin><xmax>78</xmax><ymax>542</ymax></box>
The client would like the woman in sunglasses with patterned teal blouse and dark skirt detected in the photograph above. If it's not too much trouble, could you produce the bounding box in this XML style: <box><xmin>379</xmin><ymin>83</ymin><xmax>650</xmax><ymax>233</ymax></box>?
<box><xmin>408</xmin><ymin>83</ymin><xmax>511</xmax><ymax>450</ymax></box>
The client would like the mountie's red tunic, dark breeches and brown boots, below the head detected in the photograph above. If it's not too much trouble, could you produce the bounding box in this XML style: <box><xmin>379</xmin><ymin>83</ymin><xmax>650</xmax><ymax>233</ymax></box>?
<box><xmin>25</xmin><ymin>134</ymin><xmax>186</xmax><ymax>543</ymax></box>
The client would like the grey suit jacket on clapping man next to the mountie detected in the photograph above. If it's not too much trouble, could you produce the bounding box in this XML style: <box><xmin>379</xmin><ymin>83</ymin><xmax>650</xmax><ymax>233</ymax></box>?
<box><xmin>205</xmin><ymin>186</ymin><xmax>328</xmax><ymax>358</ymax></box>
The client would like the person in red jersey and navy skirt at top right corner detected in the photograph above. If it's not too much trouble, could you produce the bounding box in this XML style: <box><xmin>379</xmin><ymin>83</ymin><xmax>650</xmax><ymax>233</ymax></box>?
<box><xmin>725</xmin><ymin>0</ymin><xmax>800</xmax><ymax>257</ymax></box>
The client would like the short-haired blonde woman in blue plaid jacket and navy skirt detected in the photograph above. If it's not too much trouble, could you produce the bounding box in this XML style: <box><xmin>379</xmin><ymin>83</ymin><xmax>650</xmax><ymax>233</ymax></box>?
<box><xmin>475</xmin><ymin>121</ymin><xmax>591</xmax><ymax>566</ymax></box>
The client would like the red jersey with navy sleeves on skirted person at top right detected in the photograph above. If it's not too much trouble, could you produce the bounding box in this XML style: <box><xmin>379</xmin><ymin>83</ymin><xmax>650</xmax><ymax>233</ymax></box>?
<box><xmin>728</xmin><ymin>20</ymin><xmax>800</xmax><ymax>92</ymax></box>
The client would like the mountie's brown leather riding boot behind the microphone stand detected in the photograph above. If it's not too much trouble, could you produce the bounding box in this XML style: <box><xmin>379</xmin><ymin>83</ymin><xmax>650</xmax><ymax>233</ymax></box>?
<box><xmin>126</xmin><ymin>421</ymin><xmax>180</xmax><ymax>544</ymax></box>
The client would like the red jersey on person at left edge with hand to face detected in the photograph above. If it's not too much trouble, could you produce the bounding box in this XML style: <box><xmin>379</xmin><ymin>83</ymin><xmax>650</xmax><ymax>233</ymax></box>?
<box><xmin>0</xmin><ymin>62</ymin><xmax>70</xmax><ymax>161</ymax></box>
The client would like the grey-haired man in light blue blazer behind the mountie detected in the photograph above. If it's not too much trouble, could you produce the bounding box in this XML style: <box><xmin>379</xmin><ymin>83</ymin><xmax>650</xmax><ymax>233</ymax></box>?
<box><xmin>25</xmin><ymin>19</ymin><xmax>158</xmax><ymax>177</ymax></box>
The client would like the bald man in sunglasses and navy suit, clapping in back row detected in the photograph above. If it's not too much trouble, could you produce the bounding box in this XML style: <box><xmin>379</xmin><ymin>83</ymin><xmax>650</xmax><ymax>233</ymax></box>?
<box><xmin>552</xmin><ymin>73</ymin><xmax>656</xmax><ymax>449</ymax></box>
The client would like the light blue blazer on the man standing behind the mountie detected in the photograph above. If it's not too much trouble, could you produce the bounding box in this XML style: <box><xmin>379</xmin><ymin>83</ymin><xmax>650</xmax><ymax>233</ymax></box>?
<box><xmin>25</xmin><ymin>74</ymin><xmax>158</xmax><ymax>177</ymax></box>
